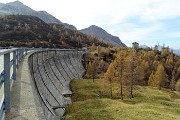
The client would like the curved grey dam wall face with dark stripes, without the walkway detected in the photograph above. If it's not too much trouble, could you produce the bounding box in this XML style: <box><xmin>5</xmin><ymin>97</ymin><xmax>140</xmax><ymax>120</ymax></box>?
<box><xmin>28</xmin><ymin>50</ymin><xmax>85</xmax><ymax>120</ymax></box>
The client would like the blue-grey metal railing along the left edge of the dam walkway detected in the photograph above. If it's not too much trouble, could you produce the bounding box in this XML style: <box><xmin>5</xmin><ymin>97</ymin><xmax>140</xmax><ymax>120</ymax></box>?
<box><xmin>0</xmin><ymin>48</ymin><xmax>27</xmax><ymax>120</ymax></box>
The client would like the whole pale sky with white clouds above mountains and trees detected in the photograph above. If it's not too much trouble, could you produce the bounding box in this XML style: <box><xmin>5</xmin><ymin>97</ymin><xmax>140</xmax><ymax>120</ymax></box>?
<box><xmin>0</xmin><ymin>0</ymin><xmax>180</xmax><ymax>49</ymax></box>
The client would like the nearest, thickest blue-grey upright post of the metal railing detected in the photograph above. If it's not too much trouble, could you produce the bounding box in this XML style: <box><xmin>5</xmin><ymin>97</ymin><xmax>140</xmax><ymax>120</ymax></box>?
<box><xmin>4</xmin><ymin>52</ymin><xmax>11</xmax><ymax>112</ymax></box>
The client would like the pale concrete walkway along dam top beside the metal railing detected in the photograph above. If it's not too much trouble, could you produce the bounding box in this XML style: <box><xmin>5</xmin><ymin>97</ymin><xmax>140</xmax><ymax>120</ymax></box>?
<box><xmin>3</xmin><ymin>54</ymin><xmax>45</xmax><ymax>120</ymax></box>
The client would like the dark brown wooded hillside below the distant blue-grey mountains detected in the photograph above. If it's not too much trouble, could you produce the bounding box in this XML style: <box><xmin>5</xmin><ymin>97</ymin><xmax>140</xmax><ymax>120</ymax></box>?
<box><xmin>0</xmin><ymin>15</ymin><xmax>108</xmax><ymax>48</ymax></box>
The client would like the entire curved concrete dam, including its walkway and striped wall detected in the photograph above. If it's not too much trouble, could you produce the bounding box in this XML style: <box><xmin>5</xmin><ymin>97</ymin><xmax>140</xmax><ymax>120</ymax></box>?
<box><xmin>0</xmin><ymin>49</ymin><xmax>85</xmax><ymax>120</ymax></box>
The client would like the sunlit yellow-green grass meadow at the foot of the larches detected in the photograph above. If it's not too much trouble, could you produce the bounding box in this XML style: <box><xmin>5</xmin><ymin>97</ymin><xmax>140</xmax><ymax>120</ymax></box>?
<box><xmin>66</xmin><ymin>80</ymin><xmax>180</xmax><ymax>120</ymax></box>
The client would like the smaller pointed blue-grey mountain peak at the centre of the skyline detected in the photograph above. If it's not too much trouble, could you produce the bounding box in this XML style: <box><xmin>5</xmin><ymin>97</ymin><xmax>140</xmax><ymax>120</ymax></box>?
<box><xmin>80</xmin><ymin>25</ymin><xmax>126</xmax><ymax>47</ymax></box>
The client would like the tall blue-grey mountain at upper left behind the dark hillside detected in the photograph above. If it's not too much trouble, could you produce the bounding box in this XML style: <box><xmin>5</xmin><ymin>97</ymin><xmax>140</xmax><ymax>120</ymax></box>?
<box><xmin>0</xmin><ymin>1</ymin><xmax>76</xmax><ymax>30</ymax></box>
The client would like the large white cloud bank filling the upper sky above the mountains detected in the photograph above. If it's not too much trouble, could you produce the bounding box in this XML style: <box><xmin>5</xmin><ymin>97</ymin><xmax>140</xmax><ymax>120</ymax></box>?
<box><xmin>1</xmin><ymin>0</ymin><xmax>180</xmax><ymax>29</ymax></box>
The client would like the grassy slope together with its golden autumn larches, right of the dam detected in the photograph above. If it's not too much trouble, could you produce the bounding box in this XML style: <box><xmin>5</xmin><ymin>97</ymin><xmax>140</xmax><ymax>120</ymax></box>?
<box><xmin>66</xmin><ymin>45</ymin><xmax>180</xmax><ymax>120</ymax></box>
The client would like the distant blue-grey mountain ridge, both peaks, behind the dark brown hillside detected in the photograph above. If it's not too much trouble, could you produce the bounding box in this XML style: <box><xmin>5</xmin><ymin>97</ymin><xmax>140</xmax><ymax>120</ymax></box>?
<box><xmin>0</xmin><ymin>1</ymin><xmax>126</xmax><ymax>47</ymax></box>
